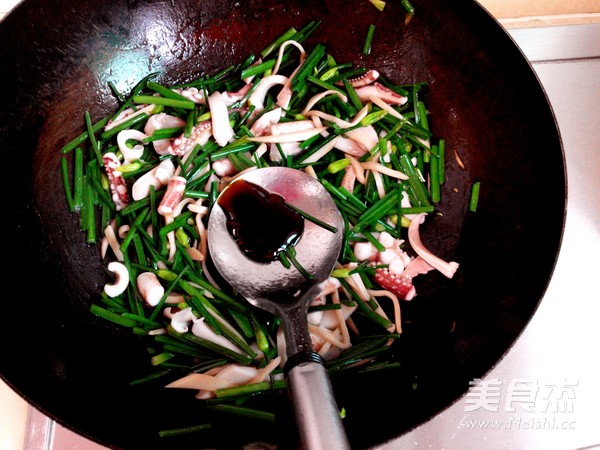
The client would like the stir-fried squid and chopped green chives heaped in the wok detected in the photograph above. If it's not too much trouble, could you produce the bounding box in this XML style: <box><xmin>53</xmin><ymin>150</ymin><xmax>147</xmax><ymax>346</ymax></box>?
<box><xmin>63</xmin><ymin>23</ymin><xmax>458</xmax><ymax>428</ymax></box>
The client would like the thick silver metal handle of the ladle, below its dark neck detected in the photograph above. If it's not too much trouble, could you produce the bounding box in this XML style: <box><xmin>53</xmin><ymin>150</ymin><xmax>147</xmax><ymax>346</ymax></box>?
<box><xmin>287</xmin><ymin>358</ymin><xmax>350</xmax><ymax>450</ymax></box>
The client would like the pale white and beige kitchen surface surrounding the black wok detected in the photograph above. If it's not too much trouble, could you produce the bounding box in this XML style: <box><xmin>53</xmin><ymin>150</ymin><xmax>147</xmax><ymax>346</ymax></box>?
<box><xmin>0</xmin><ymin>0</ymin><xmax>600</xmax><ymax>450</ymax></box>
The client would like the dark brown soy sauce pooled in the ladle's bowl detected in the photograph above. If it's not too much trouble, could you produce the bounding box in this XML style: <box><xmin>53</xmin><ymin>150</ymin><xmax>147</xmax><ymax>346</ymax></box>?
<box><xmin>217</xmin><ymin>179</ymin><xmax>304</xmax><ymax>263</ymax></box>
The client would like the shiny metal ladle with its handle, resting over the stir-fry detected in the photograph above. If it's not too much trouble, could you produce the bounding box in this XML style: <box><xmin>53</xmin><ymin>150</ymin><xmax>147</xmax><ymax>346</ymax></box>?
<box><xmin>208</xmin><ymin>167</ymin><xmax>350</xmax><ymax>450</ymax></box>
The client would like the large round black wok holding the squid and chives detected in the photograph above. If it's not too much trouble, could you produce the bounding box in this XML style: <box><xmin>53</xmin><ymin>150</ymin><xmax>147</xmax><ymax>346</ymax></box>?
<box><xmin>0</xmin><ymin>0</ymin><xmax>566</xmax><ymax>449</ymax></box>
